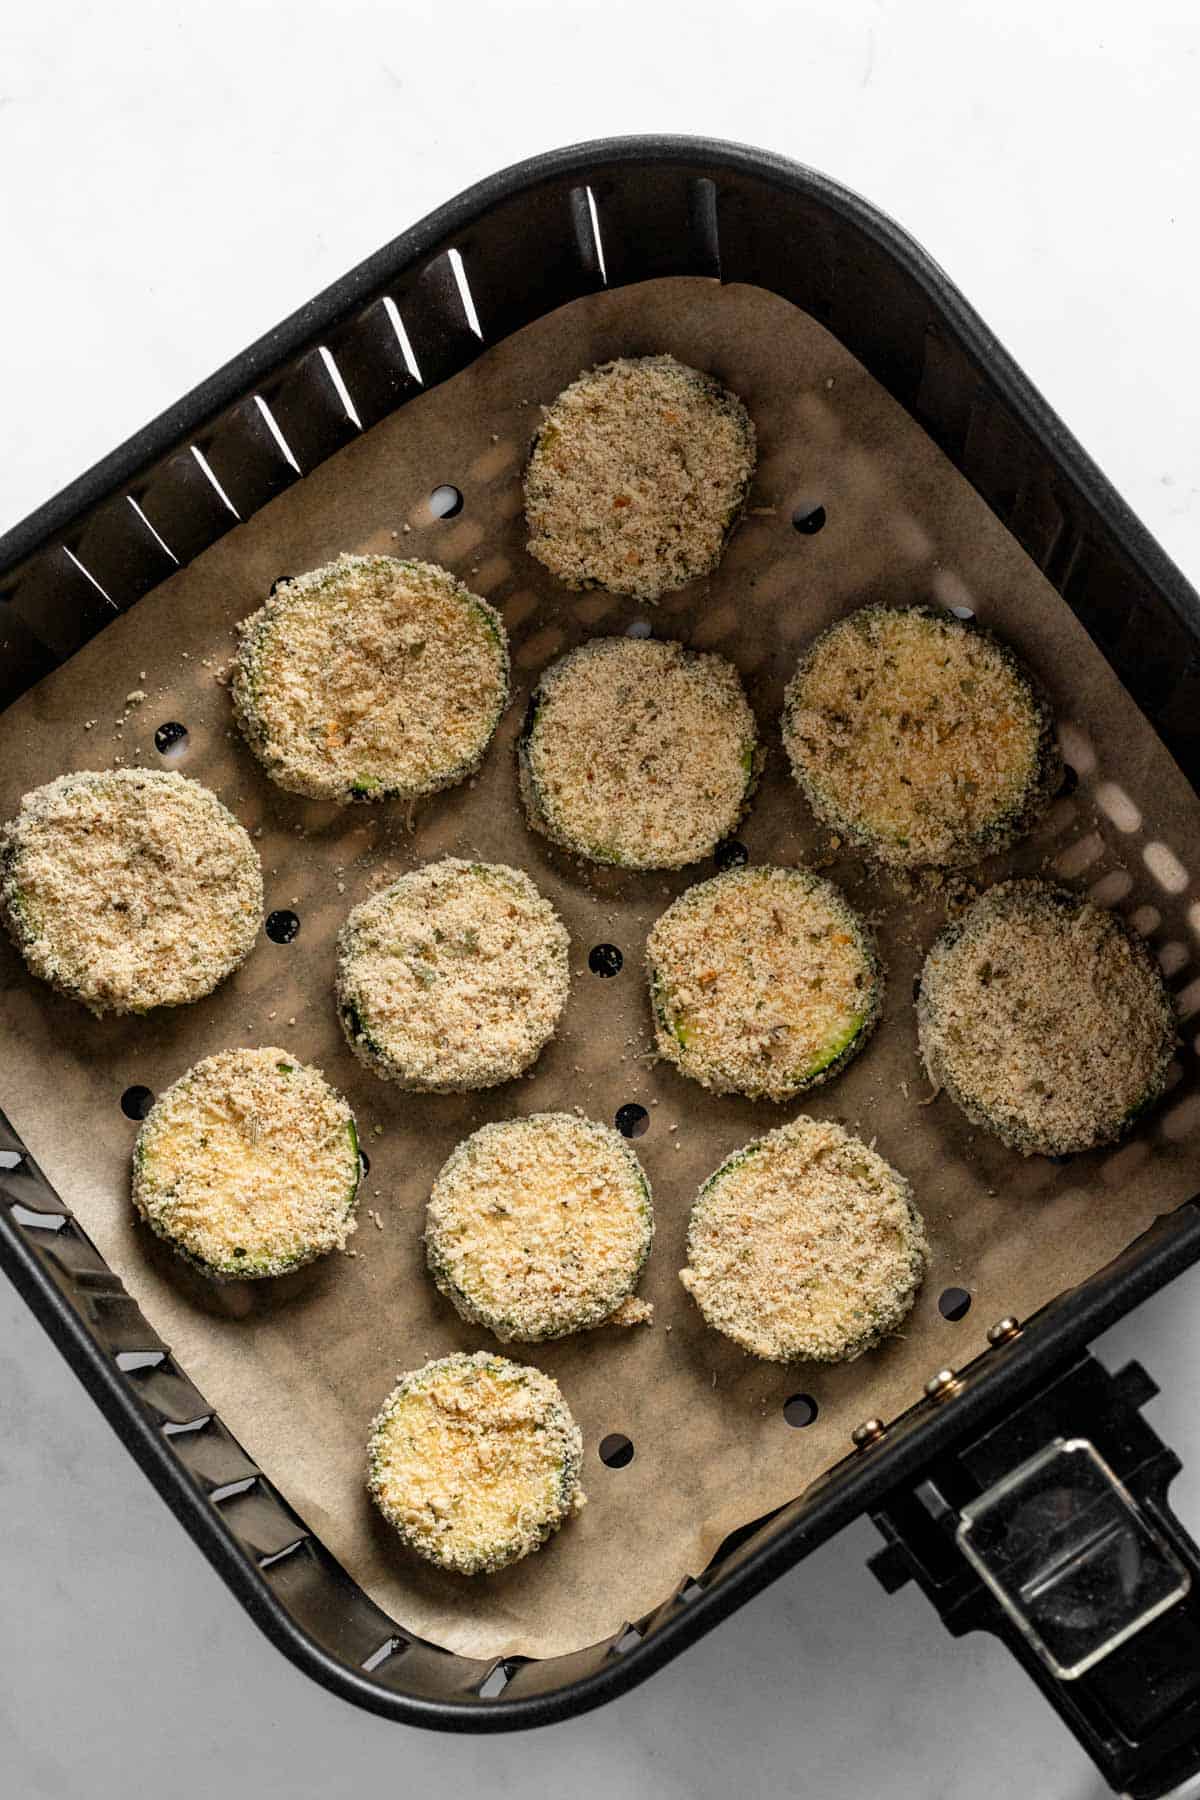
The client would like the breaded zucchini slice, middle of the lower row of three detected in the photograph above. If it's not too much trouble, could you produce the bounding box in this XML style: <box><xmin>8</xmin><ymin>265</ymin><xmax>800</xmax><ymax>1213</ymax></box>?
<box><xmin>425</xmin><ymin>1112</ymin><xmax>655</xmax><ymax>1343</ymax></box>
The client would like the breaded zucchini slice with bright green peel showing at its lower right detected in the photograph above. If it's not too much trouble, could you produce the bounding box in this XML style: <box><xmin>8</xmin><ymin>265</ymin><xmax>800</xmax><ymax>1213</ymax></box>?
<box><xmin>646</xmin><ymin>868</ymin><xmax>883</xmax><ymax>1100</ymax></box>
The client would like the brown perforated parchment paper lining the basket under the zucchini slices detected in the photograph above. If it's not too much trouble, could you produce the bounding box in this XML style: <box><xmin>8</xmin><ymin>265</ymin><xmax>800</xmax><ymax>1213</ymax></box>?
<box><xmin>0</xmin><ymin>279</ymin><xmax>1200</xmax><ymax>1656</ymax></box>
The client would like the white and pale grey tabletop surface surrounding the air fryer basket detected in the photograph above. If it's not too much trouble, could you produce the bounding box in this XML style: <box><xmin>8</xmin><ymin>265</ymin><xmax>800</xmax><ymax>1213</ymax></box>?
<box><xmin>0</xmin><ymin>0</ymin><xmax>1200</xmax><ymax>1800</ymax></box>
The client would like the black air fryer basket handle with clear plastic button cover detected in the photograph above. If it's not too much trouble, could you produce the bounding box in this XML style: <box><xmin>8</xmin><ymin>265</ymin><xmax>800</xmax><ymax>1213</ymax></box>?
<box><xmin>871</xmin><ymin>1352</ymin><xmax>1200</xmax><ymax>1800</ymax></box>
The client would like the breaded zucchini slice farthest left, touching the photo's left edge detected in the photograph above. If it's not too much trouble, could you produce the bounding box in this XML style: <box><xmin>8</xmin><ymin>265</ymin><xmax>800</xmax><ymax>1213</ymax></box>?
<box><xmin>0</xmin><ymin>769</ymin><xmax>263</xmax><ymax>1013</ymax></box>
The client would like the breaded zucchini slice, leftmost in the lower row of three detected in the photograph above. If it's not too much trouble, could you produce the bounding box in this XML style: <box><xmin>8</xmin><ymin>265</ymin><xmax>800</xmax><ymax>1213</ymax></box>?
<box><xmin>133</xmin><ymin>1048</ymin><xmax>360</xmax><ymax>1282</ymax></box>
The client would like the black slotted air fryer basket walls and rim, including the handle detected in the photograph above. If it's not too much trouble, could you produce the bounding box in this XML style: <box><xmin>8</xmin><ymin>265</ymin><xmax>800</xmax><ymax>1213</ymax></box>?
<box><xmin>0</xmin><ymin>139</ymin><xmax>1200</xmax><ymax>1796</ymax></box>
